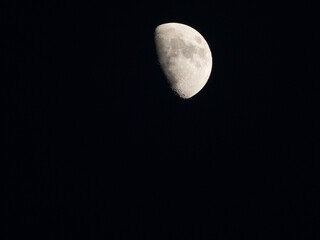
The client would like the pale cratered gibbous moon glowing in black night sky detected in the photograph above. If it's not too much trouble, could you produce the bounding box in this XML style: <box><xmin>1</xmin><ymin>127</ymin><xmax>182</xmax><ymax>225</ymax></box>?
<box><xmin>154</xmin><ymin>23</ymin><xmax>212</xmax><ymax>99</ymax></box>
